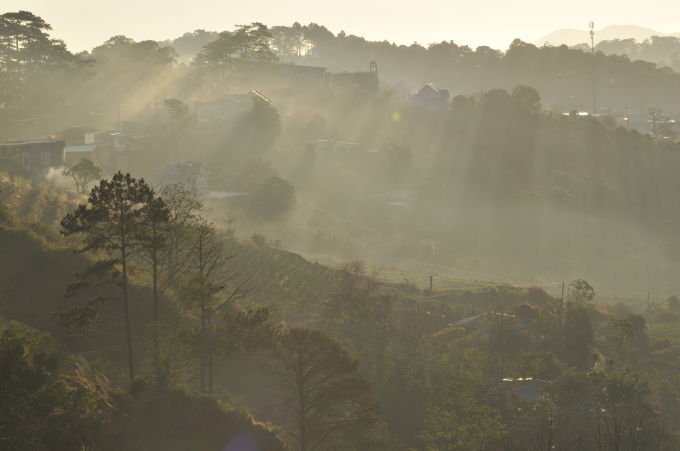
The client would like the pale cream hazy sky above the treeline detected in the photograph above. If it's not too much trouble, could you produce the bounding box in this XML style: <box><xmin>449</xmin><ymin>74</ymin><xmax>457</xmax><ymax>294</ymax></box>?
<box><xmin>5</xmin><ymin>0</ymin><xmax>680</xmax><ymax>51</ymax></box>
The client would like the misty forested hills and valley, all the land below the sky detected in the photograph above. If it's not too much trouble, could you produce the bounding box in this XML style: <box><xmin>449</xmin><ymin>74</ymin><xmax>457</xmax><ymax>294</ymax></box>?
<box><xmin>0</xmin><ymin>7</ymin><xmax>680</xmax><ymax>451</ymax></box>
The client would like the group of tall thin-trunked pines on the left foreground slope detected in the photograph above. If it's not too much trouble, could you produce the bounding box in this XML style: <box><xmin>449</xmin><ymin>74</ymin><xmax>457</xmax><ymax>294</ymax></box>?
<box><xmin>56</xmin><ymin>172</ymin><xmax>276</xmax><ymax>392</ymax></box>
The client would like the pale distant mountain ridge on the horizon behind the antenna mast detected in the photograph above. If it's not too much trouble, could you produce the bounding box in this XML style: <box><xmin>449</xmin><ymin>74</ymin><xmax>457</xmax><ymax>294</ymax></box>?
<box><xmin>535</xmin><ymin>25</ymin><xmax>680</xmax><ymax>47</ymax></box>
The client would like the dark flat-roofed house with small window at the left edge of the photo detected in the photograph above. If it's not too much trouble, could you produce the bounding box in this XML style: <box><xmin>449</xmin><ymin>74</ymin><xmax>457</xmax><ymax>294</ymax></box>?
<box><xmin>0</xmin><ymin>140</ymin><xmax>66</xmax><ymax>180</ymax></box>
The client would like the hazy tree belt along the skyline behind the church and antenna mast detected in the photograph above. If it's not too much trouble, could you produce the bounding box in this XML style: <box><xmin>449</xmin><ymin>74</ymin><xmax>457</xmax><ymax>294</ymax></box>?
<box><xmin>232</xmin><ymin>23</ymin><xmax>680</xmax><ymax>108</ymax></box>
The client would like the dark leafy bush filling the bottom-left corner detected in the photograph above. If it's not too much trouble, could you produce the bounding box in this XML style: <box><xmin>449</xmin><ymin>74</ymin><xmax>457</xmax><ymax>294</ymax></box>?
<box><xmin>0</xmin><ymin>318</ymin><xmax>108</xmax><ymax>451</ymax></box>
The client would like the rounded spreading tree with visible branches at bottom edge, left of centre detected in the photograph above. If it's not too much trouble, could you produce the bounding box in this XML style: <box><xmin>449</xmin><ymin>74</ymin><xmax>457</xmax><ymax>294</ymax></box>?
<box><xmin>265</xmin><ymin>329</ymin><xmax>379</xmax><ymax>451</ymax></box>
